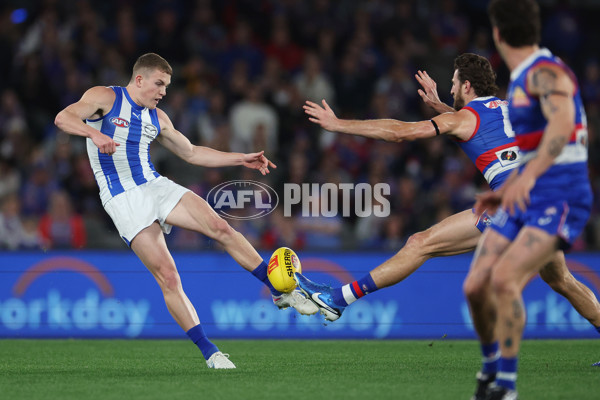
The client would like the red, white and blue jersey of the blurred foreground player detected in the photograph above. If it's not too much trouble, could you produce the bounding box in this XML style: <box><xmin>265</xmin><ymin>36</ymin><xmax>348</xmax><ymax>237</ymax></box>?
<box><xmin>508</xmin><ymin>49</ymin><xmax>589</xmax><ymax>192</ymax></box>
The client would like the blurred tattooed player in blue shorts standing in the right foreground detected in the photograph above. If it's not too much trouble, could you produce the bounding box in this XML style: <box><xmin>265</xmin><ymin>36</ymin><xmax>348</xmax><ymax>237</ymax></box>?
<box><xmin>464</xmin><ymin>0</ymin><xmax>592</xmax><ymax>399</ymax></box>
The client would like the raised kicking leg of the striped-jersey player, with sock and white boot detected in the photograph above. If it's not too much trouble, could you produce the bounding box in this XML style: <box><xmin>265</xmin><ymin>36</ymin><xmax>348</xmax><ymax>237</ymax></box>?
<box><xmin>165</xmin><ymin>192</ymin><xmax>318</xmax><ymax>315</ymax></box>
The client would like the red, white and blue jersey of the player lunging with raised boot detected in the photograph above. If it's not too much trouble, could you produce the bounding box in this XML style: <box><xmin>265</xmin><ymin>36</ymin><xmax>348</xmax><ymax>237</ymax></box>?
<box><xmin>457</xmin><ymin>96</ymin><xmax>520</xmax><ymax>190</ymax></box>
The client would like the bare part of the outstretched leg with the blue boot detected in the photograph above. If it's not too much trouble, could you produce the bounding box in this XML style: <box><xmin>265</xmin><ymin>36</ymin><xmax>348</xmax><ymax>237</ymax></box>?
<box><xmin>371</xmin><ymin>210</ymin><xmax>481</xmax><ymax>289</ymax></box>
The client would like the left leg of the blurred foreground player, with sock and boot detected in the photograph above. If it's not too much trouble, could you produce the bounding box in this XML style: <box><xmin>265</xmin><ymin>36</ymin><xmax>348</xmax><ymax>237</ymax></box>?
<box><xmin>463</xmin><ymin>229</ymin><xmax>510</xmax><ymax>400</ymax></box>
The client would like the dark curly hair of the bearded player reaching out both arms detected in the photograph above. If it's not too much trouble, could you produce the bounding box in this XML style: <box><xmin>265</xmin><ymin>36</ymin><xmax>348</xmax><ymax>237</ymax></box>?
<box><xmin>454</xmin><ymin>53</ymin><xmax>498</xmax><ymax>97</ymax></box>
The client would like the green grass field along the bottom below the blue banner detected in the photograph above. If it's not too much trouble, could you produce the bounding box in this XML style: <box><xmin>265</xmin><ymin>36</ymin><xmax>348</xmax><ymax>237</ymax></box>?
<box><xmin>0</xmin><ymin>340</ymin><xmax>600</xmax><ymax>400</ymax></box>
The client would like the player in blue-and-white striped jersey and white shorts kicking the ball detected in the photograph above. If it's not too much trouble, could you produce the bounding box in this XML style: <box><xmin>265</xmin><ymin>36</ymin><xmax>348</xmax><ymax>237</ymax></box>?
<box><xmin>55</xmin><ymin>53</ymin><xmax>317</xmax><ymax>369</ymax></box>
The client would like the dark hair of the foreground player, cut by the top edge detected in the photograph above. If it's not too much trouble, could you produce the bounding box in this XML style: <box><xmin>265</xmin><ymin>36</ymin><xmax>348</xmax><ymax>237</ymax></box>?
<box><xmin>488</xmin><ymin>0</ymin><xmax>542</xmax><ymax>47</ymax></box>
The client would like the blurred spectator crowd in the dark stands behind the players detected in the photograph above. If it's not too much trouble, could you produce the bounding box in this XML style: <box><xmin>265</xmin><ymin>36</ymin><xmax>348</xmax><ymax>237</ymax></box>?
<box><xmin>0</xmin><ymin>0</ymin><xmax>600</xmax><ymax>250</ymax></box>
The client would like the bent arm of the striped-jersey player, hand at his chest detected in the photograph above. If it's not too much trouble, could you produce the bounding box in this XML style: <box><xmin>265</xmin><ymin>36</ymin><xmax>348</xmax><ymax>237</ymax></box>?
<box><xmin>54</xmin><ymin>86</ymin><xmax>119</xmax><ymax>154</ymax></box>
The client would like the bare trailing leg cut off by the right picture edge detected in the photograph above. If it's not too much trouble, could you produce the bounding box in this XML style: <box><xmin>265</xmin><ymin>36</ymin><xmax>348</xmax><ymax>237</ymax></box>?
<box><xmin>540</xmin><ymin>251</ymin><xmax>600</xmax><ymax>328</ymax></box>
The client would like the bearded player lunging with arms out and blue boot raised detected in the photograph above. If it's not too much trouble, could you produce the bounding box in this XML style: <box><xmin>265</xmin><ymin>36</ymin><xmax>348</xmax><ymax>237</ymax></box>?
<box><xmin>296</xmin><ymin>54</ymin><xmax>600</xmax><ymax>370</ymax></box>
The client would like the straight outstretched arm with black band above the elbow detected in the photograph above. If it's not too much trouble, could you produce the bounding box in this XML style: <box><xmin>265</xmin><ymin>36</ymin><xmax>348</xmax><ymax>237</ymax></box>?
<box><xmin>304</xmin><ymin>100</ymin><xmax>477</xmax><ymax>142</ymax></box>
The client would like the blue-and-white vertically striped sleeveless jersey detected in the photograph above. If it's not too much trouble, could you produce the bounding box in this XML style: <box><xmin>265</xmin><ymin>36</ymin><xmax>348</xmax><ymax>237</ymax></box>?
<box><xmin>85</xmin><ymin>86</ymin><xmax>160</xmax><ymax>205</ymax></box>
